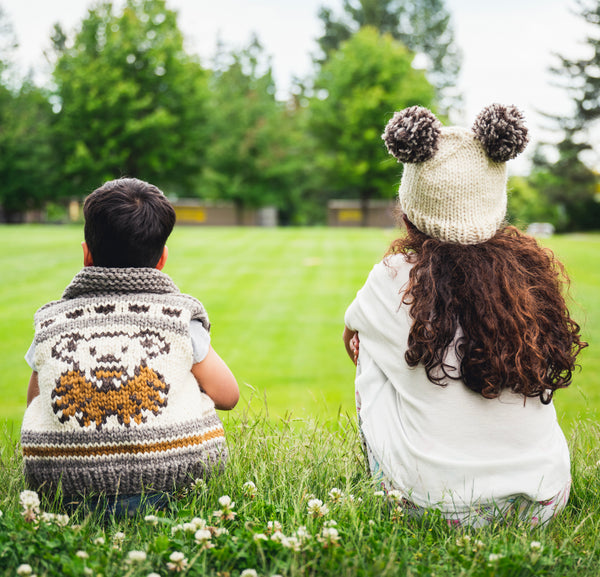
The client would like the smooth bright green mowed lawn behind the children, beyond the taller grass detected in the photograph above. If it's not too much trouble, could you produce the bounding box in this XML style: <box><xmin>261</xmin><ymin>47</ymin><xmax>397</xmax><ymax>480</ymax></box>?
<box><xmin>0</xmin><ymin>225</ymin><xmax>600</xmax><ymax>436</ymax></box>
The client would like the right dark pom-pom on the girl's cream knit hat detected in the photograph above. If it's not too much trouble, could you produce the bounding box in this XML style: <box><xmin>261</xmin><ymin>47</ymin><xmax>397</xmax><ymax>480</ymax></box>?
<box><xmin>473</xmin><ymin>104</ymin><xmax>529</xmax><ymax>162</ymax></box>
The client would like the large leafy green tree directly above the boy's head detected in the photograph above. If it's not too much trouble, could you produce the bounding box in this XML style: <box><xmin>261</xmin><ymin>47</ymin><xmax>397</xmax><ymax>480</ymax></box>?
<box><xmin>53</xmin><ymin>0</ymin><xmax>208</xmax><ymax>196</ymax></box>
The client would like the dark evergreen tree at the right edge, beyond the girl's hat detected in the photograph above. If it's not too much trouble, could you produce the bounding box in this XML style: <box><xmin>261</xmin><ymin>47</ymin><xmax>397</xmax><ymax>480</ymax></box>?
<box><xmin>530</xmin><ymin>0</ymin><xmax>600</xmax><ymax>230</ymax></box>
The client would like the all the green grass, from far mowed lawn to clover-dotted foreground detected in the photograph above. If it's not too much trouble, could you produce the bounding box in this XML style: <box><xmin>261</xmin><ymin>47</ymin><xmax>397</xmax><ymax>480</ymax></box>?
<box><xmin>0</xmin><ymin>226</ymin><xmax>600</xmax><ymax>577</ymax></box>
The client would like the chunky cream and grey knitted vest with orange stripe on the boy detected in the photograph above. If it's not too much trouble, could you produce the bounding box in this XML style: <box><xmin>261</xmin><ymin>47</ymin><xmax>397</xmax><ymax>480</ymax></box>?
<box><xmin>21</xmin><ymin>267</ymin><xmax>227</xmax><ymax>495</ymax></box>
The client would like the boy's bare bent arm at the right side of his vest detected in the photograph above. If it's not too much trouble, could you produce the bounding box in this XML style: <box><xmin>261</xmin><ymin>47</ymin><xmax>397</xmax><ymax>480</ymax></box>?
<box><xmin>192</xmin><ymin>346</ymin><xmax>240</xmax><ymax>411</ymax></box>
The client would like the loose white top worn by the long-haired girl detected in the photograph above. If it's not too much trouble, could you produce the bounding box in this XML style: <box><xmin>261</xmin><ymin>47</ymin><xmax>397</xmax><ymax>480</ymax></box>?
<box><xmin>345</xmin><ymin>255</ymin><xmax>570</xmax><ymax>511</ymax></box>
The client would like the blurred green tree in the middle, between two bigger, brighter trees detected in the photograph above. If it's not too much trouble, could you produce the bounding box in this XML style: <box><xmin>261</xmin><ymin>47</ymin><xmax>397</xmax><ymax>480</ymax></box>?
<box><xmin>199</xmin><ymin>38</ymin><xmax>298</xmax><ymax>222</ymax></box>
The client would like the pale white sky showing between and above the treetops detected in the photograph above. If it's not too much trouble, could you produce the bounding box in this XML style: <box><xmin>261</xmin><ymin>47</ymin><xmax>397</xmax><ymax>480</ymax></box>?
<box><xmin>0</xmin><ymin>0</ymin><xmax>600</xmax><ymax>173</ymax></box>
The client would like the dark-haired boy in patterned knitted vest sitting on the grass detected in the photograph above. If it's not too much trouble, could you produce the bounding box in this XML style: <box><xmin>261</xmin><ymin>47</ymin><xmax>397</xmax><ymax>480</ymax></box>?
<box><xmin>21</xmin><ymin>178</ymin><xmax>239</xmax><ymax>504</ymax></box>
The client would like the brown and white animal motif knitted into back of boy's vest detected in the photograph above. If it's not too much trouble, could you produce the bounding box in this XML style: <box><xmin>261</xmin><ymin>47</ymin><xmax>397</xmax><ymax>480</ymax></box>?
<box><xmin>51</xmin><ymin>329</ymin><xmax>170</xmax><ymax>430</ymax></box>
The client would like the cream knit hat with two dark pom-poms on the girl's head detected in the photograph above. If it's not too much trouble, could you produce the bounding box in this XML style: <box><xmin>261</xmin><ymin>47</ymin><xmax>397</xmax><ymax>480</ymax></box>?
<box><xmin>382</xmin><ymin>104</ymin><xmax>528</xmax><ymax>244</ymax></box>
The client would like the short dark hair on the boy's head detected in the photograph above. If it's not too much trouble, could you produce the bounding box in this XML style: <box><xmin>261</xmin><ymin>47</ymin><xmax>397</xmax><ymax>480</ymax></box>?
<box><xmin>83</xmin><ymin>178</ymin><xmax>175</xmax><ymax>268</ymax></box>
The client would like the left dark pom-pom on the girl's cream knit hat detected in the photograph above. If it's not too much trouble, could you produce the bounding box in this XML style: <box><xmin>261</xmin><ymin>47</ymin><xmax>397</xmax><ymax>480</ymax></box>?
<box><xmin>381</xmin><ymin>106</ymin><xmax>442</xmax><ymax>163</ymax></box>
